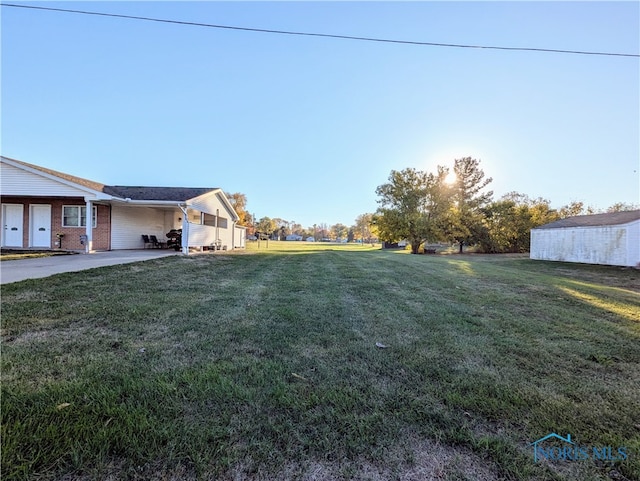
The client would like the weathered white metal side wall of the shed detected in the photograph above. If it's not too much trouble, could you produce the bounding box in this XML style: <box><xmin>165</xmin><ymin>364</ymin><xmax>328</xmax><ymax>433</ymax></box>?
<box><xmin>530</xmin><ymin>221</ymin><xmax>640</xmax><ymax>266</ymax></box>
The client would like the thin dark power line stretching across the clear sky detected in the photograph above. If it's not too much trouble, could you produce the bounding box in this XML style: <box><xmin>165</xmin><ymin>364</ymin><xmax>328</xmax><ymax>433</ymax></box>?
<box><xmin>0</xmin><ymin>3</ymin><xmax>640</xmax><ymax>58</ymax></box>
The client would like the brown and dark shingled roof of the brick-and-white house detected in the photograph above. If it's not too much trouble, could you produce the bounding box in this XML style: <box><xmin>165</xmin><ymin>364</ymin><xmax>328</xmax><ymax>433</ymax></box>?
<box><xmin>2</xmin><ymin>156</ymin><xmax>219</xmax><ymax>202</ymax></box>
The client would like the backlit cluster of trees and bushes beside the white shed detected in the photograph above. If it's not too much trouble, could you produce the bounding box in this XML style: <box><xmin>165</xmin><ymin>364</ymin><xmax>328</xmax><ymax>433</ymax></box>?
<box><xmin>372</xmin><ymin>157</ymin><xmax>640</xmax><ymax>254</ymax></box>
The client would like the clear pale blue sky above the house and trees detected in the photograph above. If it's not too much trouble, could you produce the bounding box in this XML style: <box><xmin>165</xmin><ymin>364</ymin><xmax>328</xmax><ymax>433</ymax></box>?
<box><xmin>0</xmin><ymin>0</ymin><xmax>640</xmax><ymax>227</ymax></box>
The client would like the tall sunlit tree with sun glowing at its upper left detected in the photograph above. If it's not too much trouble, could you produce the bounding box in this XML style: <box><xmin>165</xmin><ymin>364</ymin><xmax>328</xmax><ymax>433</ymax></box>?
<box><xmin>447</xmin><ymin>157</ymin><xmax>493</xmax><ymax>253</ymax></box>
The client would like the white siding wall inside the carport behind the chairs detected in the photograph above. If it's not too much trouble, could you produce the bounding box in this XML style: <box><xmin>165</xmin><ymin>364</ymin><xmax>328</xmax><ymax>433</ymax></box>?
<box><xmin>111</xmin><ymin>205</ymin><xmax>180</xmax><ymax>249</ymax></box>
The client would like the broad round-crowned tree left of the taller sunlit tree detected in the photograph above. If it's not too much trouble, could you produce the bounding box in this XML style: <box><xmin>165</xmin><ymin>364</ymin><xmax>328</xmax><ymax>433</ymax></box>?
<box><xmin>374</xmin><ymin>166</ymin><xmax>450</xmax><ymax>254</ymax></box>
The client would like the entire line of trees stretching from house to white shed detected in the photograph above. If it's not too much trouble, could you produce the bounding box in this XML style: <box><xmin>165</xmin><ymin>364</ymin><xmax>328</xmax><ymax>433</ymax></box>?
<box><xmin>226</xmin><ymin>157</ymin><xmax>640</xmax><ymax>254</ymax></box>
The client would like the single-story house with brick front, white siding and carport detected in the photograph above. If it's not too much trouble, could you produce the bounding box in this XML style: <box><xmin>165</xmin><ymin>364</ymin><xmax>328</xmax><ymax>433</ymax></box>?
<box><xmin>0</xmin><ymin>157</ymin><xmax>246</xmax><ymax>254</ymax></box>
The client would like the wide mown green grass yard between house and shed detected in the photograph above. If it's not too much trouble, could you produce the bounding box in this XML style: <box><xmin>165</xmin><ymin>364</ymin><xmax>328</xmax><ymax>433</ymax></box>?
<box><xmin>1</xmin><ymin>242</ymin><xmax>640</xmax><ymax>481</ymax></box>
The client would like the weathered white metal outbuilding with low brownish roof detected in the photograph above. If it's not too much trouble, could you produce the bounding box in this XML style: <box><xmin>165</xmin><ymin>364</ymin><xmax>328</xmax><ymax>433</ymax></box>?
<box><xmin>530</xmin><ymin>210</ymin><xmax>640</xmax><ymax>267</ymax></box>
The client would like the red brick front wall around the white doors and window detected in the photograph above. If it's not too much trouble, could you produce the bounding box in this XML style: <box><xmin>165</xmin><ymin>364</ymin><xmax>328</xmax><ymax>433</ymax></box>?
<box><xmin>2</xmin><ymin>196</ymin><xmax>111</xmax><ymax>250</ymax></box>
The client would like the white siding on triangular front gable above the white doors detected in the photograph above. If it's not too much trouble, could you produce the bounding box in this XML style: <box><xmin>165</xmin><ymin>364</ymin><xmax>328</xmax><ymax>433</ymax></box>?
<box><xmin>0</xmin><ymin>162</ymin><xmax>96</xmax><ymax>199</ymax></box>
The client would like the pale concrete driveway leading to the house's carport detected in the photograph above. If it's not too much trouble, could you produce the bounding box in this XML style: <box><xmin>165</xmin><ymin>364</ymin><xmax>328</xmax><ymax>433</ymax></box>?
<box><xmin>0</xmin><ymin>249</ymin><xmax>181</xmax><ymax>284</ymax></box>
